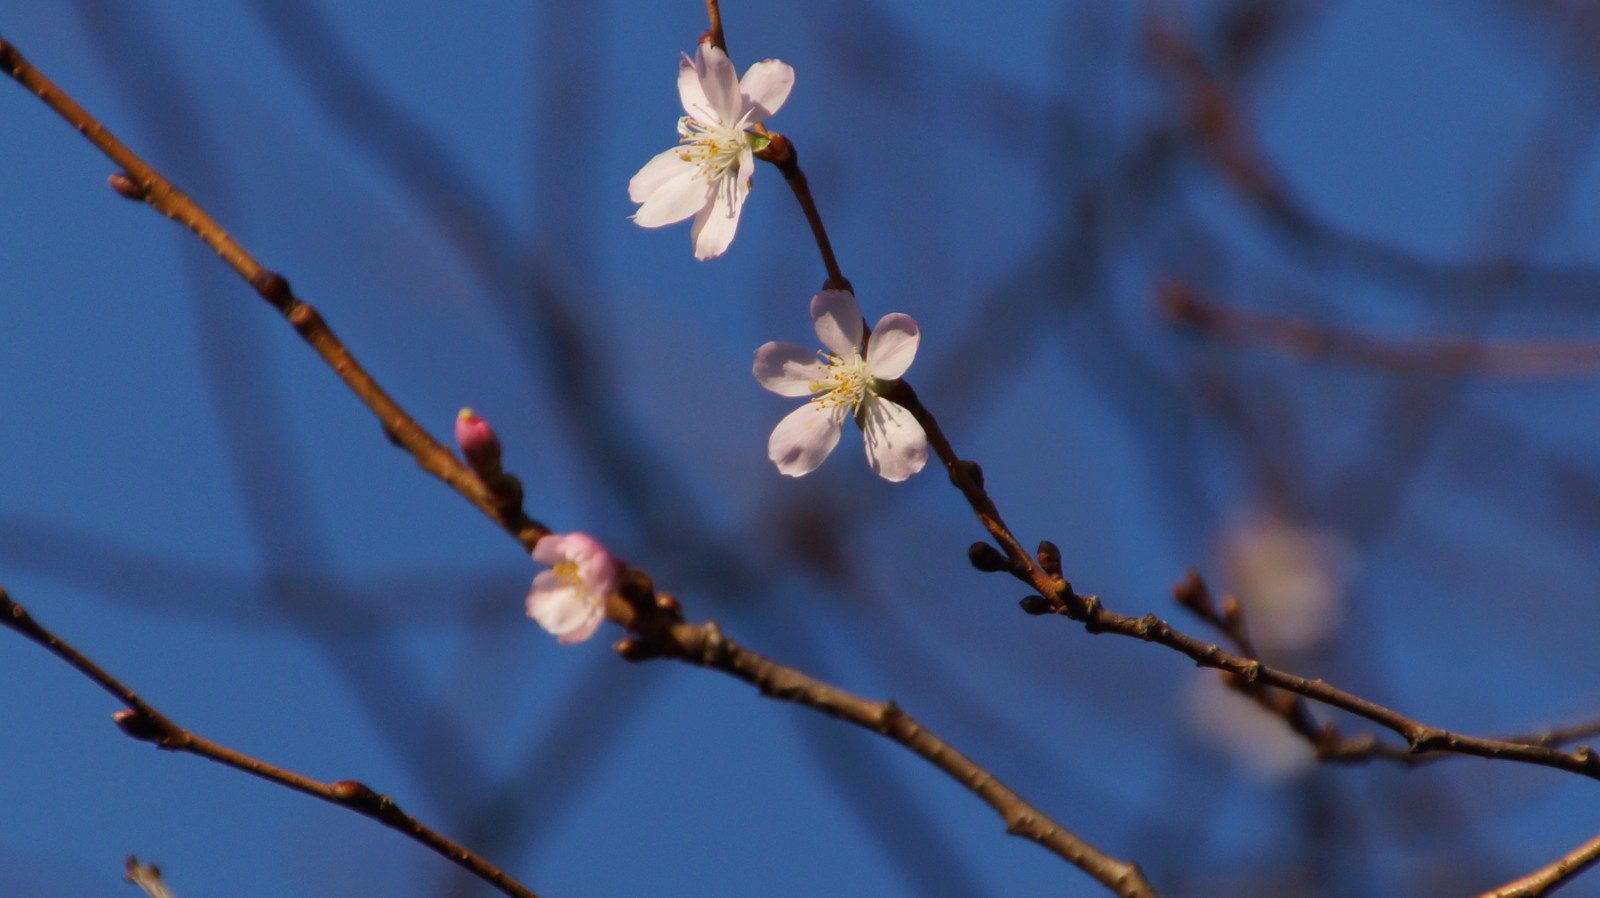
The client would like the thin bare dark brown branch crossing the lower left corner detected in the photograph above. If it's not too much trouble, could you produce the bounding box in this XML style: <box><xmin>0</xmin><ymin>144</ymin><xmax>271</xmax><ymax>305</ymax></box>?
<box><xmin>0</xmin><ymin>587</ymin><xmax>538</xmax><ymax>898</ymax></box>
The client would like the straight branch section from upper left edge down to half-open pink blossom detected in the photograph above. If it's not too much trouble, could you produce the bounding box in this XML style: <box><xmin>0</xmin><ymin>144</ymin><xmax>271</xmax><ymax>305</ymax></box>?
<box><xmin>0</xmin><ymin>37</ymin><xmax>549</xmax><ymax>549</ymax></box>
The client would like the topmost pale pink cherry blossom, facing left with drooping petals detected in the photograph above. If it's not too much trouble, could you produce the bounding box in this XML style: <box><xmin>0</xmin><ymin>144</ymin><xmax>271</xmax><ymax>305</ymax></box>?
<box><xmin>627</xmin><ymin>42</ymin><xmax>795</xmax><ymax>259</ymax></box>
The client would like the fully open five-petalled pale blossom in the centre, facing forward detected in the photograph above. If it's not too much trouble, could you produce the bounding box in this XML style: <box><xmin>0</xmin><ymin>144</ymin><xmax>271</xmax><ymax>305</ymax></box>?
<box><xmin>754</xmin><ymin>290</ymin><xmax>928</xmax><ymax>482</ymax></box>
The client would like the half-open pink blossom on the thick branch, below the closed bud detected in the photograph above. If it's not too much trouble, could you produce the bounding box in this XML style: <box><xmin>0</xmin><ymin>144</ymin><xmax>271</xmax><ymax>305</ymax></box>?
<box><xmin>528</xmin><ymin>533</ymin><xmax>618</xmax><ymax>645</ymax></box>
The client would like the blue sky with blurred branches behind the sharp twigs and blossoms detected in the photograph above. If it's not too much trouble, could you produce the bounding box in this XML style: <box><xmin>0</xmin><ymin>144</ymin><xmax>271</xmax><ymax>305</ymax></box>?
<box><xmin>0</xmin><ymin>0</ymin><xmax>1600</xmax><ymax>898</ymax></box>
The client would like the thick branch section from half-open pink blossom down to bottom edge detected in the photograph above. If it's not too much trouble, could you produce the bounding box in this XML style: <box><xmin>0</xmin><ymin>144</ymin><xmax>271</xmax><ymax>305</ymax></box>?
<box><xmin>606</xmin><ymin>595</ymin><xmax>1157</xmax><ymax>898</ymax></box>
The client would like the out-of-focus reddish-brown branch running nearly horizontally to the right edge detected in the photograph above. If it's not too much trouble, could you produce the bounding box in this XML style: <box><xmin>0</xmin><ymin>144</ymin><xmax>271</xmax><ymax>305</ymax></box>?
<box><xmin>1157</xmin><ymin>280</ymin><xmax>1600</xmax><ymax>379</ymax></box>
